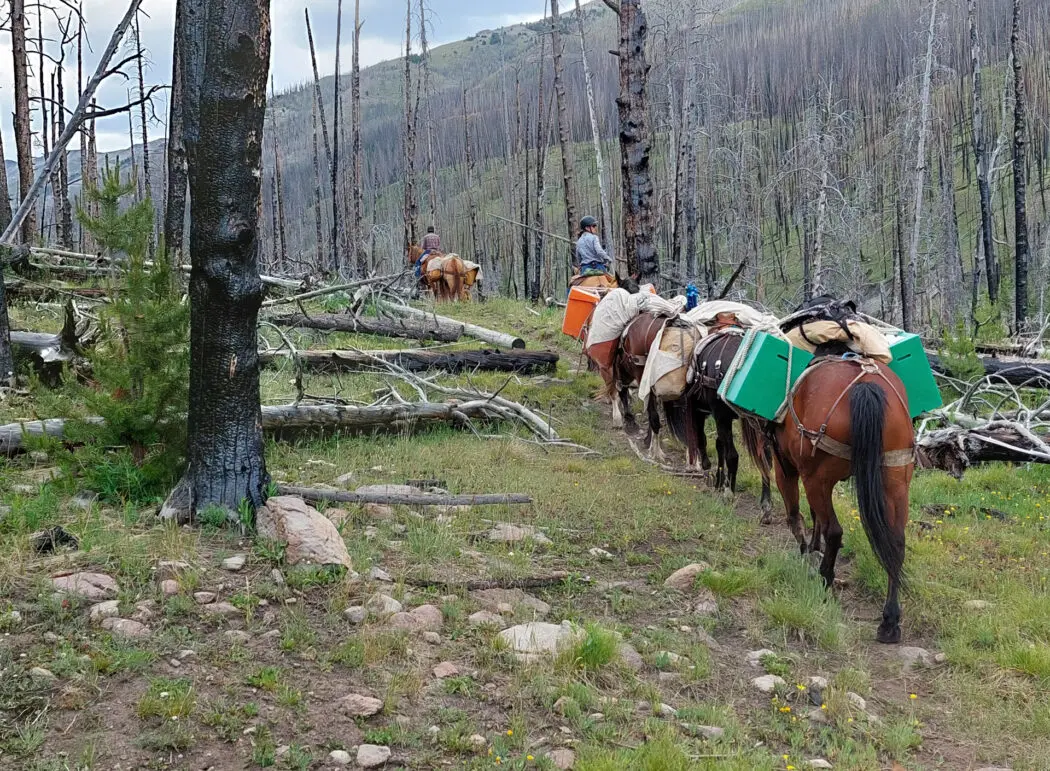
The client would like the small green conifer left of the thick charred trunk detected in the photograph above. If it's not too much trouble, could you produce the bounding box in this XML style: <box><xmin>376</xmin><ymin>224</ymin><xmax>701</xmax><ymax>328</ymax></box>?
<box><xmin>70</xmin><ymin>166</ymin><xmax>189</xmax><ymax>500</ymax></box>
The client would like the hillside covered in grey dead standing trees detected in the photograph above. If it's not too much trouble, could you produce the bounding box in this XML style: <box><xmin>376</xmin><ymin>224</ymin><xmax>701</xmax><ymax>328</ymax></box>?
<box><xmin>12</xmin><ymin>0</ymin><xmax>1050</xmax><ymax>329</ymax></box>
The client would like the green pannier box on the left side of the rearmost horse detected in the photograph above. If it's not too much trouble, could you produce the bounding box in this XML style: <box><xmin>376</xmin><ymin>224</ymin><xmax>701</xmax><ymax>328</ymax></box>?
<box><xmin>718</xmin><ymin>330</ymin><xmax>813</xmax><ymax>420</ymax></box>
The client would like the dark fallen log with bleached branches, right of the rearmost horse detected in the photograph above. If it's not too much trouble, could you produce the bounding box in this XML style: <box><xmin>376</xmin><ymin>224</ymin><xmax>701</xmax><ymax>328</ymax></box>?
<box><xmin>916</xmin><ymin>422</ymin><xmax>1050</xmax><ymax>479</ymax></box>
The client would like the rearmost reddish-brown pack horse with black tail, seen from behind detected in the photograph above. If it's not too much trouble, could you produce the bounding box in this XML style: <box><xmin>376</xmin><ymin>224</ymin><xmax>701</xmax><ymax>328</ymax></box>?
<box><xmin>770</xmin><ymin>348</ymin><xmax>915</xmax><ymax>643</ymax></box>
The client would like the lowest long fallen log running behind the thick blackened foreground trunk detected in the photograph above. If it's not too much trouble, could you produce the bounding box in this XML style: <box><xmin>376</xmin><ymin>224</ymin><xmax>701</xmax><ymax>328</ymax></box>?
<box><xmin>0</xmin><ymin>398</ymin><xmax>558</xmax><ymax>456</ymax></box>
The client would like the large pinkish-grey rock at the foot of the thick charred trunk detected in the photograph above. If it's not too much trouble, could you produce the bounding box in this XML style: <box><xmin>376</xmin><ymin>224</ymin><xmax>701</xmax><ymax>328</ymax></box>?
<box><xmin>255</xmin><ymin>496</ymin><xmax>353</xmax><ymax>569</ymax></box>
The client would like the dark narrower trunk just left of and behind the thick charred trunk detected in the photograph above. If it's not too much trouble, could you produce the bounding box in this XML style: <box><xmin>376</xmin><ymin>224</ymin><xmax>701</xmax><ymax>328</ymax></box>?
<box><xmin>164</xmin><ymin>2</ymin><xmax>187</xmax><ymax>265</ymax></box>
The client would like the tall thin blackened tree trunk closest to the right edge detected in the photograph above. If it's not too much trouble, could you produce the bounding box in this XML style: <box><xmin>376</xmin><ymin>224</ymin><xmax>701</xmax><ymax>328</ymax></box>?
<box><xmin>1010</xmin><ymin>0</ymin><xmax>1028</xmax><ymax>333</ymax></box>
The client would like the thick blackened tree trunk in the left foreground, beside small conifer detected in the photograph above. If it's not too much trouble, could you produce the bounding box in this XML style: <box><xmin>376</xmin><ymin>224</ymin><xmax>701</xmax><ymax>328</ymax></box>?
<box><xmin>162</xmin><ymin>0</ymin><xmax>270</xmax><ymax>520</ymax></box>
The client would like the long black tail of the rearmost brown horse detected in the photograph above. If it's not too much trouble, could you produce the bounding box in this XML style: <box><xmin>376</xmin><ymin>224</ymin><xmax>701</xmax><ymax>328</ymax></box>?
<box><xmin>849</xmin><ymin>382</ymin><xmax>904</xmax><ymax>592</ymax></box>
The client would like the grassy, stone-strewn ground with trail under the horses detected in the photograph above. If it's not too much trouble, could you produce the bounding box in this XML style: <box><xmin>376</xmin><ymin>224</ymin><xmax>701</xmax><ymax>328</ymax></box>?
<box><xmin>0</xmin><ymin>301</ymin><xmax>1050</xmax><ymax>771</ymax></box>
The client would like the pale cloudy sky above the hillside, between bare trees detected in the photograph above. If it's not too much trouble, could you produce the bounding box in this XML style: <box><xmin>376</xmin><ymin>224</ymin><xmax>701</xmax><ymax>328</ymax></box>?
<box><xmin>0</xmin><ymin>0</ymin><xmax>546</xmax><ymax>160</ymax></box>
